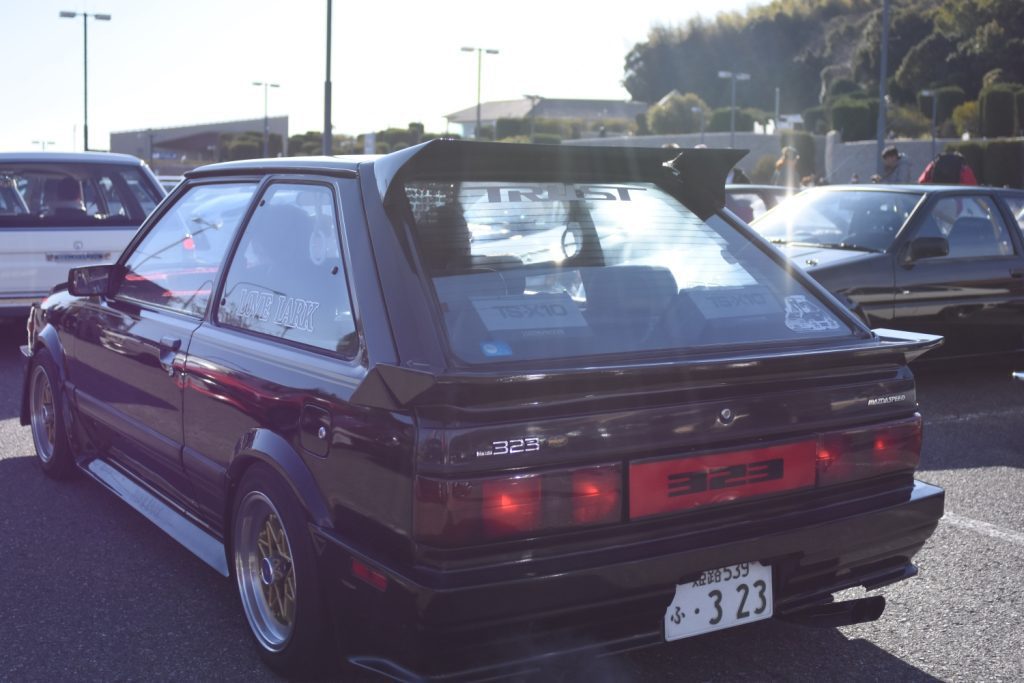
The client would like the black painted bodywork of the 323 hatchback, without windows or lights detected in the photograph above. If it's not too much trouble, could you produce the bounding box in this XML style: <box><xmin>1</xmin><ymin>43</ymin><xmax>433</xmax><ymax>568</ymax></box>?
<box><xmin>24</xmin><ymin>142</ymin><xmax>943</xmax><ymax>678</ymax></box>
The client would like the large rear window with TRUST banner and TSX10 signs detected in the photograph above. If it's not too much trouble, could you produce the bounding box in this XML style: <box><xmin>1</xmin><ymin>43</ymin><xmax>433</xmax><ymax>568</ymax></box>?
<box><xmin>404</xmin><ymin>181</ymin><xmax>853</xmax><ymax>364</ymax></box>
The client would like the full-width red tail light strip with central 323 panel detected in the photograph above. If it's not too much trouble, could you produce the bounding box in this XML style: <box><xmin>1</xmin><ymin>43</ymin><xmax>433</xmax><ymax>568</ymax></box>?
<box><xmin>415</xmin><ymin>415</ymin><xmax>922</xmax><ymax>546</ymax></box>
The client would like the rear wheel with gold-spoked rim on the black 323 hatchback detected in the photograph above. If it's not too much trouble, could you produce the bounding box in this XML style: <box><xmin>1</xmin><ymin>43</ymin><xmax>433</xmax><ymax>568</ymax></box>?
<box><xmin>231</xmin><ymin>464</ymin><xmax>333</xmax><ymax>678</ymax></box>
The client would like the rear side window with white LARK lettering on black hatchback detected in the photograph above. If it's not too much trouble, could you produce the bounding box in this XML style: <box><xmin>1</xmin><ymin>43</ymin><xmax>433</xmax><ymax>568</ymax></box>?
<box><xmin>217</xmin><ymin>183</ymin><xmax>357</xmax><ymax>357</ymax></box>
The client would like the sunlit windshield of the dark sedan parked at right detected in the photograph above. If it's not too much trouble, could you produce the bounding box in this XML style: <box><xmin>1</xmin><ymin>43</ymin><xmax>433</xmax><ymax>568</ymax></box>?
<box><xmin>752</xmin><ymin>189</ymin><xmax>921</xmax><ymax>251</ymax></box>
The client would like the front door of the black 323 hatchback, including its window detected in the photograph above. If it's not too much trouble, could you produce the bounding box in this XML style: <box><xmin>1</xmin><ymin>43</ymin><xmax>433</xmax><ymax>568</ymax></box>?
<box><xmin>70</xmin><ymin>183</ymin><xmax>256</xmax><ymax>498</ymax></box>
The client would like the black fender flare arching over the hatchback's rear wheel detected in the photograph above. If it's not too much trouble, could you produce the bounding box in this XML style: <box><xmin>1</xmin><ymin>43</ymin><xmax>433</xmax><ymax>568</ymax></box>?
<box><xmin>223</xmin><ymin>428</ymin><xmax>332</xmax><ymax>529</ymax></box>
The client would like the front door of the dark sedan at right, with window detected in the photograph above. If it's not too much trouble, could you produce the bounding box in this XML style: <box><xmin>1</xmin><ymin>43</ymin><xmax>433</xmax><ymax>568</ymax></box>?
<box><xmin>893</xmin><ymin>191</ymin><xmax>1024</xmax><ymax>353</ymax></box>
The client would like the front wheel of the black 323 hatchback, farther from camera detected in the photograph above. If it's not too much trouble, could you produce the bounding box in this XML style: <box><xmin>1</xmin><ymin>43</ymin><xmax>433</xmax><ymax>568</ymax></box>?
<box><xmin>29</xmin><ymin>348</ymin><xmax>78</xmax><ymax>479</ymax></box>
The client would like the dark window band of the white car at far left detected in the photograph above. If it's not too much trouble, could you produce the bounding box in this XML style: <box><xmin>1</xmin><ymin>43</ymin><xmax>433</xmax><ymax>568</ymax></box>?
<box><xmin>0</xmin><ymin>163</ymin><xmax>164</xmax><ymax>228</ymax></box>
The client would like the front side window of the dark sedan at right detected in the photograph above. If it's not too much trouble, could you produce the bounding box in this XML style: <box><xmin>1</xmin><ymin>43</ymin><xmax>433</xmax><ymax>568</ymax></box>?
<box><xmin>918</xmin><ymin>196</ymin><xmax>1014</xmax><ymax>258</ymax></box>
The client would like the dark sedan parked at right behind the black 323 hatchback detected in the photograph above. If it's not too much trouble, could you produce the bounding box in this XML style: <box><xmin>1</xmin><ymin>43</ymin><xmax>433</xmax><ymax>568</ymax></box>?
<box><xmin>754</xmin><ymin>185</ymin><xmax>1024</xmax><ymax>354</ymax></box>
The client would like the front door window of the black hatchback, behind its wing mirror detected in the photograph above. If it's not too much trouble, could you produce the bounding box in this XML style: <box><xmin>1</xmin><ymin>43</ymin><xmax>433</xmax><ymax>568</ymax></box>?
<box><xmin>118</xmin><ymin>183</ymin><xmax>256</xmax><ymax>315</ymax></box>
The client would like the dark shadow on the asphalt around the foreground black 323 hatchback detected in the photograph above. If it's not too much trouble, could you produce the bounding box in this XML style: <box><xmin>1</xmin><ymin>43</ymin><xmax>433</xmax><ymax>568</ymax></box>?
<box><xmin>0</xmin><ymin>454</ymin><xmax>933</xmax><ymax>683</ymax></box>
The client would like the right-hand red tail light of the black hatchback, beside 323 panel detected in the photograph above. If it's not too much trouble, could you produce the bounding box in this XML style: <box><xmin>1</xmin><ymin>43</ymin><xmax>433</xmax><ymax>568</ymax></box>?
<box><xmin>817</xmin><ymin>415</ymin><xmax>923</xmax><ymax>485</ymax></box>
